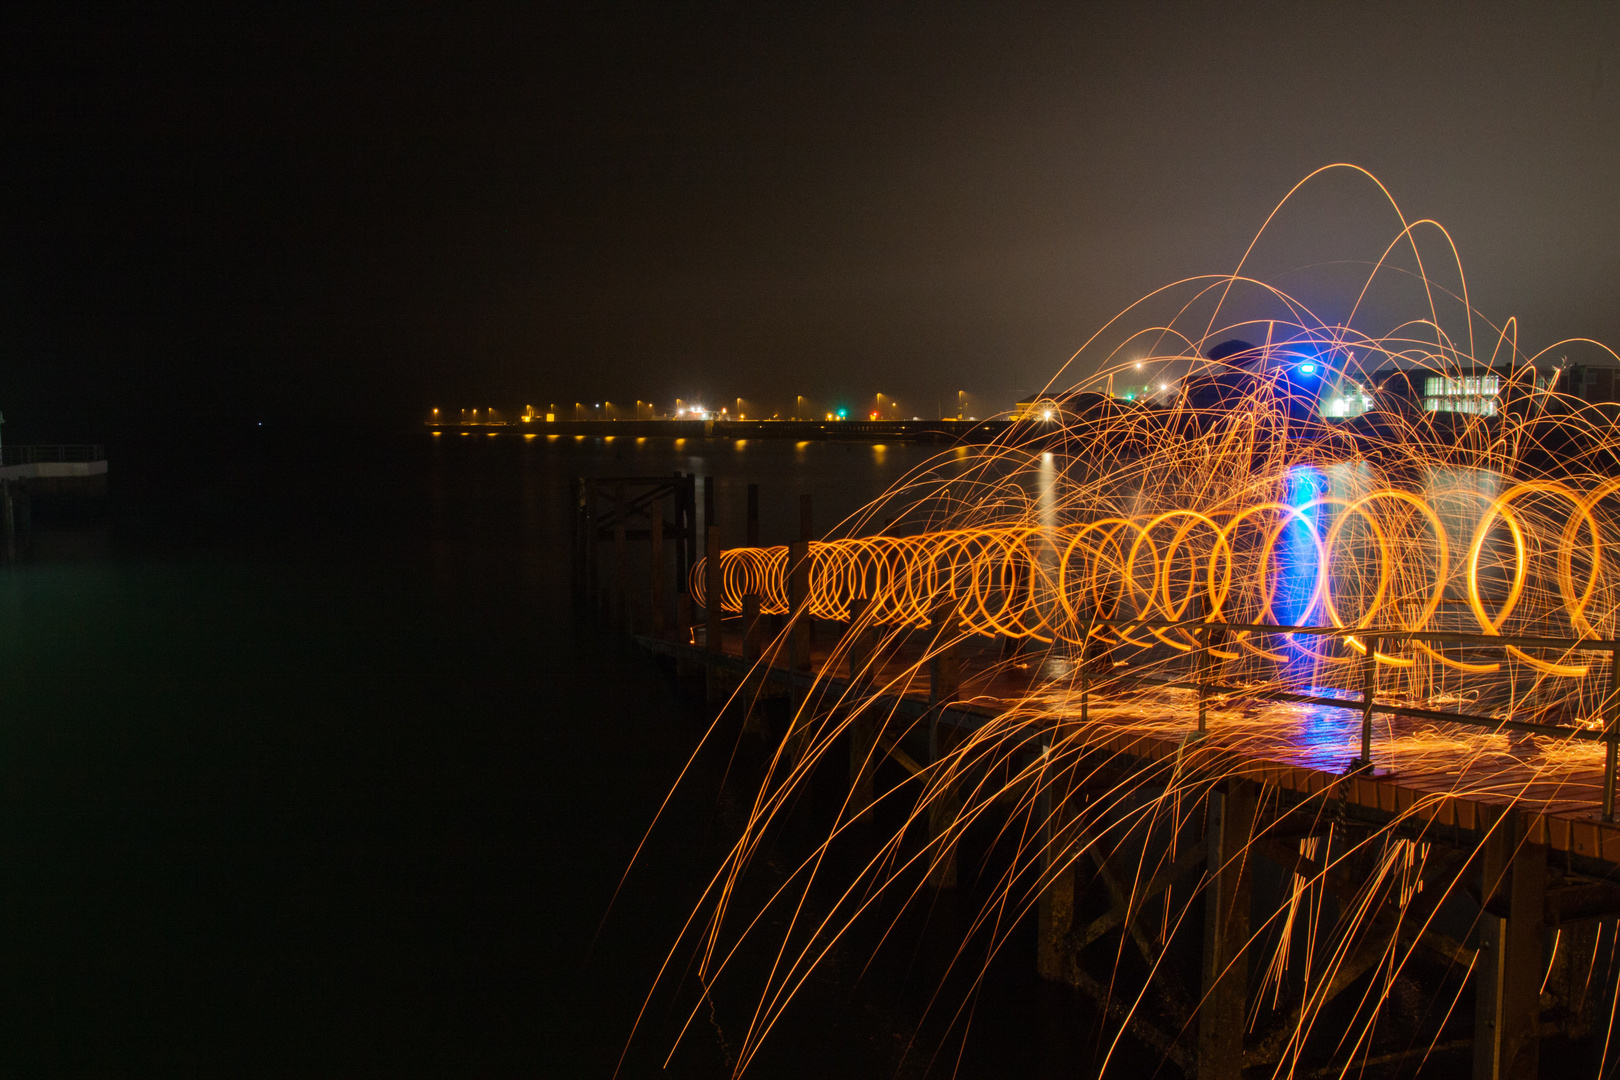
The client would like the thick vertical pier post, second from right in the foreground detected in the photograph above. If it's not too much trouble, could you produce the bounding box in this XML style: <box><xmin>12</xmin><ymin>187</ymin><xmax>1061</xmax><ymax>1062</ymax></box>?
<box><xmin>1197</xmin><ymin>777</ymin><xmax>1257</xmax><ymax>1080</ymax></box>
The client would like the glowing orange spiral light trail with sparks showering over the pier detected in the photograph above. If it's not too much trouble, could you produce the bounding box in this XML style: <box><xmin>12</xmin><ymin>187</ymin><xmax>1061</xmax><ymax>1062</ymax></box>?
<box><xmin>631</xmin><ymin>167</ymin><xmax>1620</xmax><ymax>1077</ymax></box>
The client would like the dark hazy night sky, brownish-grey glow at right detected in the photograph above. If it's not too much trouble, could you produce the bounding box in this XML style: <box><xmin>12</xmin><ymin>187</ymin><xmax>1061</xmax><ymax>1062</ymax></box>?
<box><xmin>0</xmin><ymin>3</ymin><xmax>1620</xmax><ymax>436</ymax></box>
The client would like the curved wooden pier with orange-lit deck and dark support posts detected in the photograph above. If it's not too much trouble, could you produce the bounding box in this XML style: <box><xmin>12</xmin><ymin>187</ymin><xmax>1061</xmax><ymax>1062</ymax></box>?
<box><xmin>577</xmin><ymin>478</ymin><xmax>1620</xmax><ymax>1080</ymax></box>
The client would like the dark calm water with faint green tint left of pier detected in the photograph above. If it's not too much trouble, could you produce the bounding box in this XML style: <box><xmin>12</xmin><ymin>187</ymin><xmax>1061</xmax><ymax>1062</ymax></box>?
<box><xmin>0</xmin><ymin>437</ymin><xmax>1108</xmax><ymax>1077</ymax></box>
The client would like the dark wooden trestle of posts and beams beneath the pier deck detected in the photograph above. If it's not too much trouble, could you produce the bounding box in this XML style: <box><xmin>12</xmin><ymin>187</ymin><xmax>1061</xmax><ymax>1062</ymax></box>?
<box><xmin>582</xmin><ymin>481</ymin><xmax>1620</xmax><ymax>1080</ymax></box>
